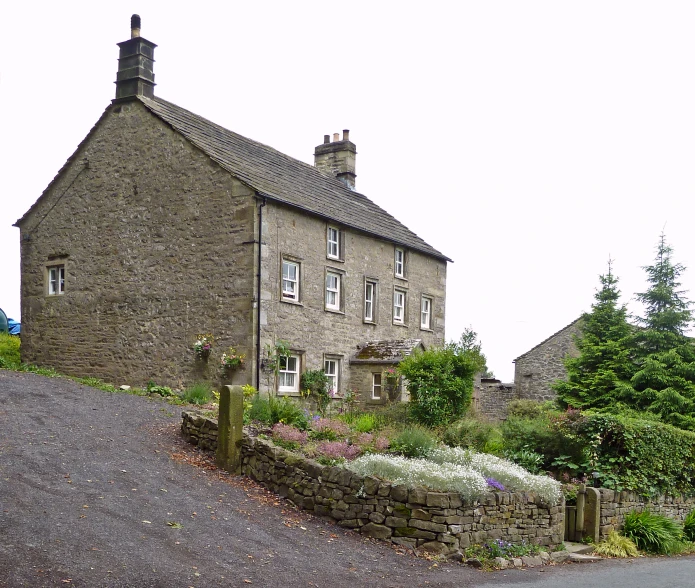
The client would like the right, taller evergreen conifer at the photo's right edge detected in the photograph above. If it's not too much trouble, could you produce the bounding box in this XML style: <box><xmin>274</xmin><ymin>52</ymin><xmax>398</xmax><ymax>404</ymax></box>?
<box><xmin>623</xmin><ymin>233</ymin><xmax>695</xmax><ymax>430</ymax></box>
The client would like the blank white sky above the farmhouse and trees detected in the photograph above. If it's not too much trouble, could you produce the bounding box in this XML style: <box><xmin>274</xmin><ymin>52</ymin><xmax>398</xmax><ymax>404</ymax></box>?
<box><xmin>0</xmin><ymin>0</ymin><xmax>695</xmax><ymax>381</ymax></box>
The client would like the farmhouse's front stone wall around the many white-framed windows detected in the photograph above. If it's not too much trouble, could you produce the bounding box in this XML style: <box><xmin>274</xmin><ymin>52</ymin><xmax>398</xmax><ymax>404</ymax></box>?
<box><xmin>261</xmin><ymin>202</ymin><xmax>446</xmax><ymax>393</ymax></box>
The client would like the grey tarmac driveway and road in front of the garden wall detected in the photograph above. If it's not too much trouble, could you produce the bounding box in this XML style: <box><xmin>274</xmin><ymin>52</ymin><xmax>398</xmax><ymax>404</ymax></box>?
<box><xmin>0</xmin><ymin>370</ymin><xmax>695</xmax><ymax>588</ymax></box>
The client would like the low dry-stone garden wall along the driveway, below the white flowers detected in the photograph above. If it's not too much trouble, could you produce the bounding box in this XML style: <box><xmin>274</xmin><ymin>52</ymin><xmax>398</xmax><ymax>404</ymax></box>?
<box><xmin>182</xmin><ymin>412</ymin><xmax>564</xmax><ymax>553</ymax></box>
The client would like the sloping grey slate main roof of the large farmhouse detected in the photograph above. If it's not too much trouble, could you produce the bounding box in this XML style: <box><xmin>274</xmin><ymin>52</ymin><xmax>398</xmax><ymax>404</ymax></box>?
<box><xmin>138</xmin><ymin>96</ymin><xmax>451</xmax><ymax>261</ymax></box>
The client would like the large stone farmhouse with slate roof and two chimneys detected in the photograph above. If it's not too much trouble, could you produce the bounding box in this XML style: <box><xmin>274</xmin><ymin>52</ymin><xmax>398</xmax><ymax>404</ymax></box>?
<box><xmin>15</xmin><ymin>15</ymin><xmax>450</xmax><ymax>402</ymax></box>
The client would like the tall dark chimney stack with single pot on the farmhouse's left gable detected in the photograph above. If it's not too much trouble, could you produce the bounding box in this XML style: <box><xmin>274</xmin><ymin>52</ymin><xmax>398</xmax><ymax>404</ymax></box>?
<box><xmin>116</xmin><ymin>14</ymin><xmax>157</xmax><ymax>100</ymax></box>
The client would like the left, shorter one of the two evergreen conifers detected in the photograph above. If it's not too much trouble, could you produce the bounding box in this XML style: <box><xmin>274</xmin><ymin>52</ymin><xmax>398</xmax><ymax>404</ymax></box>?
<box><xmin>553</xmin><ymin>259</ymin><xmax>633</xmax><ymax>409</ymax></box>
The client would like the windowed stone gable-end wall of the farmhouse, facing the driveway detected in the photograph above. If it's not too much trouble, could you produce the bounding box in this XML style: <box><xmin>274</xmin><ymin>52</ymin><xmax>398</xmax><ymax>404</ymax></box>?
<box><xmin>21</xmin><ymin>101</ymin><xmax>255</xmax><ymax>387</ymax></box>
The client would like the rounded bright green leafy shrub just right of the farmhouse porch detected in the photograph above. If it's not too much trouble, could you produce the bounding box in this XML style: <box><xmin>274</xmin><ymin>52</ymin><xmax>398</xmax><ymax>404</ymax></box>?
<box><xmin>398</xmin><ymin>345</ymin><xmax>485</xmax><ymax>427</ymax></box>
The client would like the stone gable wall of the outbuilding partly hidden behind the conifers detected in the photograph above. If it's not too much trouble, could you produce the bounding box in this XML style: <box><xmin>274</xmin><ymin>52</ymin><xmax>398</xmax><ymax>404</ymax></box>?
<box><xmin>514</xmin><ymin>320</ymin><xmax>580</xmax><ymax>401</ymax></box>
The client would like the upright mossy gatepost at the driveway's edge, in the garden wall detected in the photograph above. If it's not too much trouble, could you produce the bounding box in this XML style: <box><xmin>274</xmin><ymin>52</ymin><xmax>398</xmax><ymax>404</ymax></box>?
<box><xmin>215</xmin><ymin>386</ymin><xmax>244</xmax><ymax>474</ymax></box>
